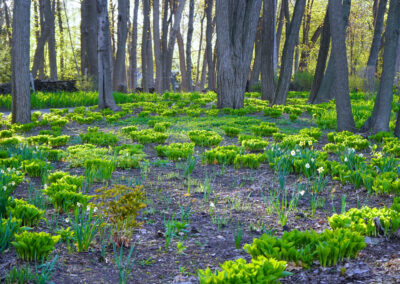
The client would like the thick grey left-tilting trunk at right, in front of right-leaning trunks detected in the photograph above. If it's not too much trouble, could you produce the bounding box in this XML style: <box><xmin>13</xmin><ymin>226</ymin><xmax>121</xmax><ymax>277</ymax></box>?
<box><xmin>328</xmin><ymin>0</ymin><xmax>356</xmax><ymax>131</ymax></box>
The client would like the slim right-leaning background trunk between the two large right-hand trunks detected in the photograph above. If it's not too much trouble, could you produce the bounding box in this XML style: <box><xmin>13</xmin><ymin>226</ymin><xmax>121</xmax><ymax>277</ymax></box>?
<box><xmin>365</xmin><ymin>0</ymin><xmax>387</xmax><ymax>93</ymax></box>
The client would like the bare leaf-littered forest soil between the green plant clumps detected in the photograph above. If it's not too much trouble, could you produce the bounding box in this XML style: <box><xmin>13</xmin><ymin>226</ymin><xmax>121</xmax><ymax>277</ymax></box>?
<box><xmin>0</xmin><ymin>93</ymin><xmax>400</xmax><ymax>283</ymax></box>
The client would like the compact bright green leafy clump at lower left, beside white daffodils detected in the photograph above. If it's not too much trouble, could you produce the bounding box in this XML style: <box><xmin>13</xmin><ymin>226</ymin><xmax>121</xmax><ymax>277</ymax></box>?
<box><xmin>11</xmin><ymin>232</ymin><xmax>60</xmax><ymax>261</ymax></box>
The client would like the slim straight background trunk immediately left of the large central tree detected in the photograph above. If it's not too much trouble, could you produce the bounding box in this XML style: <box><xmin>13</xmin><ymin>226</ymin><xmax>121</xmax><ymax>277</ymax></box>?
<box><xmin>205</xmin><ymin>0</ymin><xmax>215</xmax><ymax>90</ymax></box>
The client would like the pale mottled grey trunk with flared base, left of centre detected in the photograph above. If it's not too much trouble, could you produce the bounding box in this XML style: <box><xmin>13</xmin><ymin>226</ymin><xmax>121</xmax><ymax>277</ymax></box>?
<box><xmin>97</xmin><ymin>0</ymin><xmax>120</xmax><ymax>111</ymax></box>
